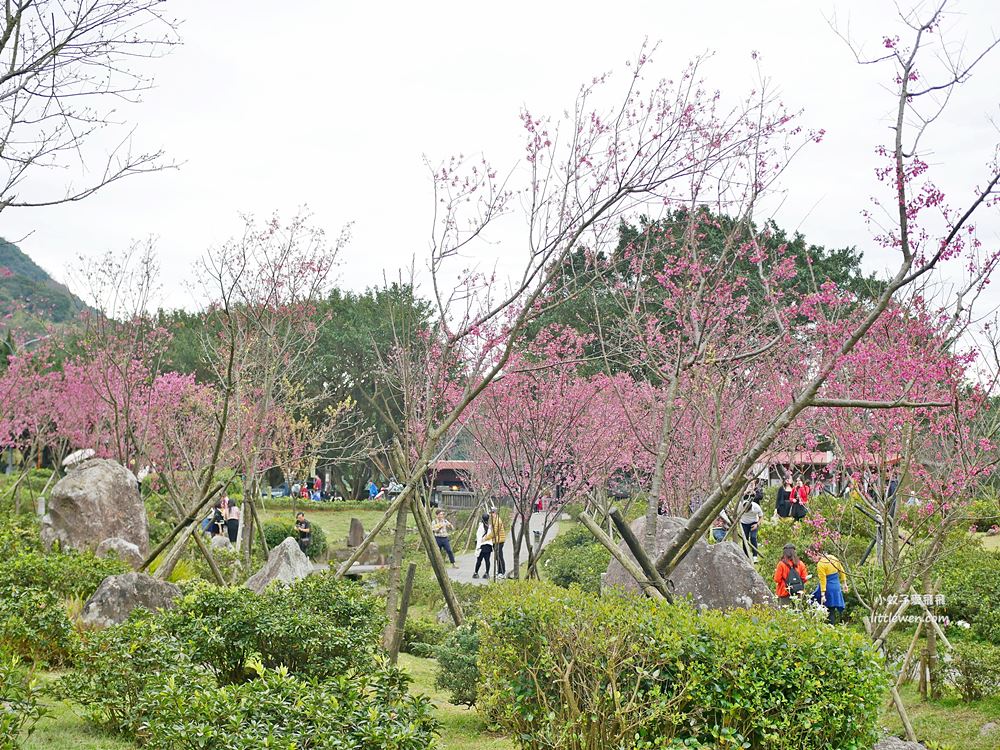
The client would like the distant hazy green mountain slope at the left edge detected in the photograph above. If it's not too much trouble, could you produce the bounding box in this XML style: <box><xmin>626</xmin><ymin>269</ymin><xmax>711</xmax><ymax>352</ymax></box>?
<box><xmin>0</xmin><ymin>237</ymin><xmax>86</xmax><ymax>328</ymax></box>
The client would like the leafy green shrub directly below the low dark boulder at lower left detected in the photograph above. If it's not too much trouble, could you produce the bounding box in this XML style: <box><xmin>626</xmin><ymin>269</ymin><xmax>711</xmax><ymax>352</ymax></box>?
<box><xmin>53</xmin><ymin>615</ymin><xmax>207</xmax><ymax>738</ymax></box>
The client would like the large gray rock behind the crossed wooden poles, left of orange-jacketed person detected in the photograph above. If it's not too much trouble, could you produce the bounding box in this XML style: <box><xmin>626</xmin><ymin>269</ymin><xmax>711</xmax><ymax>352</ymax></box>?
<box><xmin>602</xmin><ymin>516</ymin><xmax>777</xmax><ymax>609</ymax></box>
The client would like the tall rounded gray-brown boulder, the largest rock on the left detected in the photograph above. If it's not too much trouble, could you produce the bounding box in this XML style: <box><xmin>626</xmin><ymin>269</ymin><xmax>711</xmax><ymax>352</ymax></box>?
<box><xmin>42</xmin><ymin>458</ymin><xmax>149</xmax><ymax>555</ymax></box>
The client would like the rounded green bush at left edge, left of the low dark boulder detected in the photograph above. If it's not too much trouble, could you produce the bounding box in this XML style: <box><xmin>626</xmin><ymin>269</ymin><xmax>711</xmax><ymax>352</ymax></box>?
<box><xmin>0</xmin><ymin>585</ymin><xmax>73</xmax><ymax>666</ymax></box>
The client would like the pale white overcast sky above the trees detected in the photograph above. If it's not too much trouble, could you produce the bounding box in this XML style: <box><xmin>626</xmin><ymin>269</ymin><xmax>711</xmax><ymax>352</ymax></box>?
<box><xmin>0</xmin><ymin>0</ymin><xmax>1000</xmax><ymax>306</ymax></box>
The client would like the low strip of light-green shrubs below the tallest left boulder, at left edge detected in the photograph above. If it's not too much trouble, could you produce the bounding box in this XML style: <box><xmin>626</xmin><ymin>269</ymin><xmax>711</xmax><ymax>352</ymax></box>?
<box><xmin>0</xmin><ymin>551</ymin><xmax>131</xmax><ymax>598</ymax></box>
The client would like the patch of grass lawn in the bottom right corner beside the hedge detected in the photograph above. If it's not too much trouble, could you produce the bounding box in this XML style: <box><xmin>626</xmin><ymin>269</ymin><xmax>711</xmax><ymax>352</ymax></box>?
<box><xmin>882</xmin><ymin>685</ymin><xmax>1000</xmax><ymax>750</ymax></box>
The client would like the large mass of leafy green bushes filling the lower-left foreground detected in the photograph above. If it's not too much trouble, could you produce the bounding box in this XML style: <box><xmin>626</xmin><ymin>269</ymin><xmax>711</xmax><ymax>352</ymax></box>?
<box><xmin>56</xmin><ymin>575</ymin><xmax>437</xmax><ymax>750</ymax></box>
